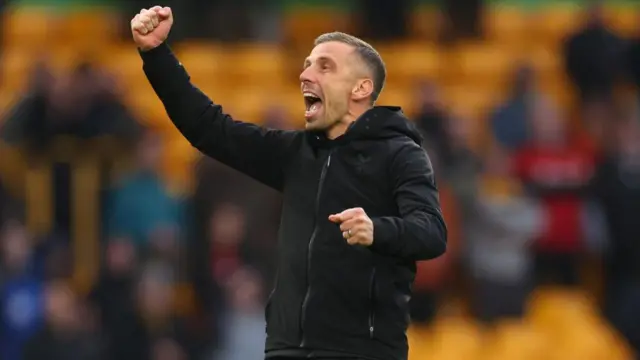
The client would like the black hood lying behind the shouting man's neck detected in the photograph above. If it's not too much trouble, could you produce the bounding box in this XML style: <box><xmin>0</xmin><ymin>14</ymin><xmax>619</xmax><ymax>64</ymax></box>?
<box><xmin>310</xmin><ymin>106</ymin><xmax>422</xmax><ymax>145</ymax></box>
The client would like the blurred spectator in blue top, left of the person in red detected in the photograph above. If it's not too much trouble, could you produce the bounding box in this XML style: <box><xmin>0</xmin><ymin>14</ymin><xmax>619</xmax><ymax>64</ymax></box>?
<box><xmin>491</xmin><ymin>64</ymin><xmax>538</xmax><ymax>150</ymax></box>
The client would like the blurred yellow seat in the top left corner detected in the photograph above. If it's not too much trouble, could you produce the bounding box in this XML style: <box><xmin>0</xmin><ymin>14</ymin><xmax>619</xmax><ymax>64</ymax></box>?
<box><xmin>2</xmin><ymin>7</ymin><xmax>59</xmax><ymax>50</ymax></box>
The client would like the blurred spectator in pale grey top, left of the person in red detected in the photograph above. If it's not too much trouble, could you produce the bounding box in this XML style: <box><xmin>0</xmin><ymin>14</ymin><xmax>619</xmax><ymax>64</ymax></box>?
<box><xmin>468</xmin><ymin>147</ymin><xmax>544</xmax><ymax>323</ymax></box>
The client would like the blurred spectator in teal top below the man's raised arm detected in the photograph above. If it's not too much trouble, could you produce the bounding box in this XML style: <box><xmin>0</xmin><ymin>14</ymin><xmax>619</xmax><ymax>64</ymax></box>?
<box><xmin>106</xmin><ymin>132</ymin><xmax>183</xmax><ymax>250</ymax></box>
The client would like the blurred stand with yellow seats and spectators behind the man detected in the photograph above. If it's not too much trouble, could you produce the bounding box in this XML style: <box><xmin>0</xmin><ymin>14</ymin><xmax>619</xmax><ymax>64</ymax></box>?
<box><xmin>0</xmin><ymin>0</ymin><xmax>640</xmax><ymax>360</ymax></box>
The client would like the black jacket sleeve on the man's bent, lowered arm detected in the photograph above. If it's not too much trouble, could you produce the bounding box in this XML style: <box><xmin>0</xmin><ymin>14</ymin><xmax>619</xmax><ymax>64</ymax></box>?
<box><xmin>371</xmin><ymin>144</ymin><xmax>447</xmax><ymax>261</ymax></box>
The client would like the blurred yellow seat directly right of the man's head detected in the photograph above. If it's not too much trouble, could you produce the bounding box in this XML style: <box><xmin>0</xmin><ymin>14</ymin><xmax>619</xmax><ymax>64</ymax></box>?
<box><xmin>378</xmin><ymin>42</ymin><xmax>442</xmax><ymax>81</ymax></box>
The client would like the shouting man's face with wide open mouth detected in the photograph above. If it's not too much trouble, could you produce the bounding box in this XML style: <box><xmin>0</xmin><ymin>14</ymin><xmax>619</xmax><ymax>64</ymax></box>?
<box><xmin>300</xmin><ymin>41</ymin><xmax>361</xmax><ymax>130</ymax></box>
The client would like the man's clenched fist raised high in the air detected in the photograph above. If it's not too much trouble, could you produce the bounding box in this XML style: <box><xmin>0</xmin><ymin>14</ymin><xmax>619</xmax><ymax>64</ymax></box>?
<box><xmin>131</xmin><ymin>6</ymin><xmax>173</xmax><ymax>51</ymax></box>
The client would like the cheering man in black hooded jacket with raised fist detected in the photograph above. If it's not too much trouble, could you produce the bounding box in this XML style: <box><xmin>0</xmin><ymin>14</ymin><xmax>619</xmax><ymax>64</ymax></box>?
<box><xmin>131</xmin><ymin>7</ymin><xmax>446</xmax><ymax>360</ymax></box>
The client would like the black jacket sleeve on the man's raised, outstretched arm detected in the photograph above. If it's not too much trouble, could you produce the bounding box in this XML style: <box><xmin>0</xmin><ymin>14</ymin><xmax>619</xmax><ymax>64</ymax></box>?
<box><xmin>140</xmin><ymin>44</ymin><xmax>297</xmax><ymax>190</ymax></box>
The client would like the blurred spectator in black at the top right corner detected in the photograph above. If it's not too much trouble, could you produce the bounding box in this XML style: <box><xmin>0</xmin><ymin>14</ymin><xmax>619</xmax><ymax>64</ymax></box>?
<box><xmin>564</xmin><ymin>0</ymin><xmax>625</xmax><ymax>101</ymax></box>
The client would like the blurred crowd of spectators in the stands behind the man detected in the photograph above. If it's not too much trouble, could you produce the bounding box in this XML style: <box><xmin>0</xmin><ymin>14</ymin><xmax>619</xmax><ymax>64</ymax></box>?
<box><xmin>0</xmin><ymin>1</ymin><xmax>640</xmax><ymax>360</ymax></box>
